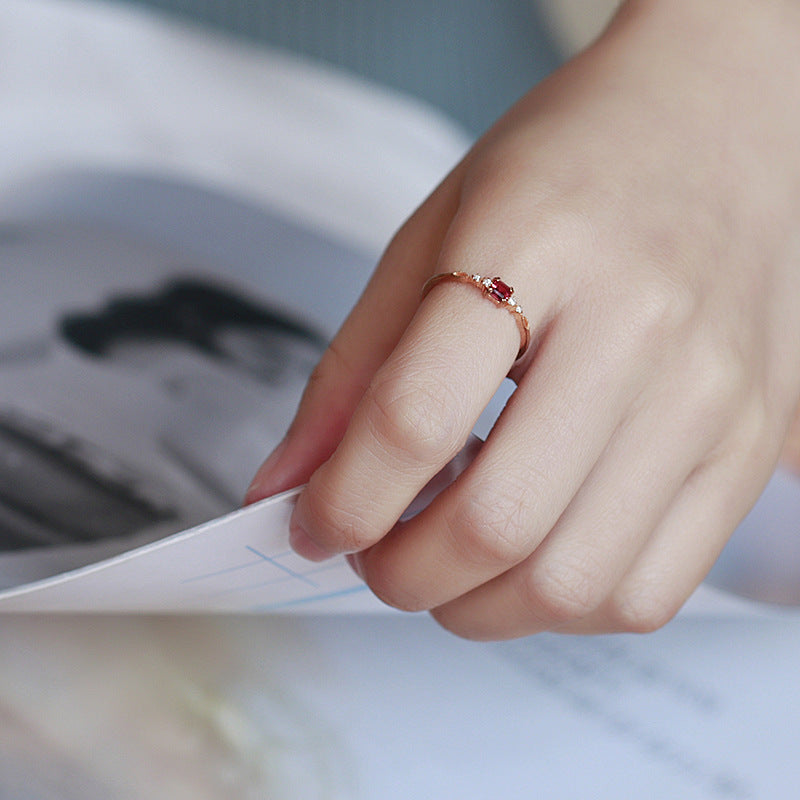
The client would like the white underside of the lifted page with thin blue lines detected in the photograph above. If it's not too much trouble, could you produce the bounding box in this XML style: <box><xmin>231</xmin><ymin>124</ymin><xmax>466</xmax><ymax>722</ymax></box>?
<box><xmin>0</xmin><ymin>490</ymin><xmax>381</xmax><ymax>613</ymax></box>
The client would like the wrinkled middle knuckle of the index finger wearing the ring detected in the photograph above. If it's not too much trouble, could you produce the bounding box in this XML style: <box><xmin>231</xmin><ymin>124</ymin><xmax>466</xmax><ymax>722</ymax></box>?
<box><xmin>367</xmin><ymin>378</ymin><xmax>466</xmax><ymax>464</ymax></box>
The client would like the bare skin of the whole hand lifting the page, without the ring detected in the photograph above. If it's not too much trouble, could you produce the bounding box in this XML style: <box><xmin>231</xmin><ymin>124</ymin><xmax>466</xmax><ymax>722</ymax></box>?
<box><xmin>248</xmin><ymin>0</ymin><xmax>800</xmax><ymax>639</ymax></box>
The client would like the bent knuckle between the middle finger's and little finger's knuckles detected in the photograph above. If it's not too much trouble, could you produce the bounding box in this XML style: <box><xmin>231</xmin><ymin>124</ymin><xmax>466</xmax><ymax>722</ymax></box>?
<box><xmin>521</xmin><ymin>556</ymin><xmax>604</xmax><ymax>627</ymax></box>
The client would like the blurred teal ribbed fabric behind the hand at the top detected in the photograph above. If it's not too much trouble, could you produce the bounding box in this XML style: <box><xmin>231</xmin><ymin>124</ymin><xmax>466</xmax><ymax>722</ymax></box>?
<box><xmin>106</xmin><ymin>0</ymin><xmax>558</xmax><ymax>133</ymax></box>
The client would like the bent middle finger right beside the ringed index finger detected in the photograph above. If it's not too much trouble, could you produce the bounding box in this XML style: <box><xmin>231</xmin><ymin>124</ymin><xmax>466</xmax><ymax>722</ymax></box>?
<box><xmin>356</xmin><ymin>290</ymin><xmax>656</xmax><ymax>610</ymax></box>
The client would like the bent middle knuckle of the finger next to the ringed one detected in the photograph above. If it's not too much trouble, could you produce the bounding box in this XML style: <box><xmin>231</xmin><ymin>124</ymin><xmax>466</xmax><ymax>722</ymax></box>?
<box><xmin>448</xmin><ymin>490</ymin><xmax>532</xmax><ymax>567</ymax></box>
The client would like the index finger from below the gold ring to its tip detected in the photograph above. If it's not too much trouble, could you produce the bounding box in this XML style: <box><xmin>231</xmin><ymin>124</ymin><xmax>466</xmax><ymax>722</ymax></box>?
<box><xmin>292</xmin><ymin>276</ymin><xmax>519</xmax><ymax>554</ymax></box>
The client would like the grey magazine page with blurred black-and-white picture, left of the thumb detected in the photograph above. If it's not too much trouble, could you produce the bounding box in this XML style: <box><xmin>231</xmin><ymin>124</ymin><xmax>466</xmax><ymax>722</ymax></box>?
<box><xmin>0</xmin><ymin>175</ymin><xmax>363</xmax><ymax>600</ymax></box>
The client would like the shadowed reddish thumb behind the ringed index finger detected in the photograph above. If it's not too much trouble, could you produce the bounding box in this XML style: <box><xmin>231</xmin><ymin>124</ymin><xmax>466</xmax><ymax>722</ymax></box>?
<box><xmin>245</xmin><ymin>166</ymin><xmax>462</xmax><ymax>503</ymax></box>
